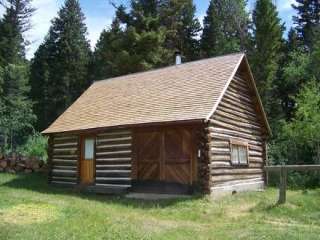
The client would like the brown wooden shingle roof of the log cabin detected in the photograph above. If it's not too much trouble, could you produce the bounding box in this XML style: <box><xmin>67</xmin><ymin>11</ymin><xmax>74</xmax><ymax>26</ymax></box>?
<box><xmin>43</xmin><ymin>54</ymin><xmax>264</xmax><ymax>134</ymax></box>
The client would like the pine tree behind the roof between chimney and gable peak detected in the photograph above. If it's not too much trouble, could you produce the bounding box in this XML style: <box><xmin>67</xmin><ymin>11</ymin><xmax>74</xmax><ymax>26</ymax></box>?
<box><xmin>201</xmin><ymin>0</ymin><xmax>249</xmax><ymax>57</ymax></box>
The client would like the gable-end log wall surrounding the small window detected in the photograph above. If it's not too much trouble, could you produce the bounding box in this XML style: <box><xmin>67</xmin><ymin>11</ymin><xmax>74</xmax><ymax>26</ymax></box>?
<box><xmin>207</xmin><ymin>75</ymin><xmax>265</xmax><ymax>188</ymax></box>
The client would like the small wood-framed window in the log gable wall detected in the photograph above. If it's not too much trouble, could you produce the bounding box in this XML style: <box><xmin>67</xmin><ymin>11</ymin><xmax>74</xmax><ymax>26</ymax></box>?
<box><xmin>230</xmin><ymin>140</ymin><xmax>249</xmax><ymax>166</ymax></box>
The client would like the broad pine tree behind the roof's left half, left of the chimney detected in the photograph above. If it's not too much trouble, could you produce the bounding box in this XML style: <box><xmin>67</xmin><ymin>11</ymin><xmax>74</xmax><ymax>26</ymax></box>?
<box><xmin>94</xmin><ymin>0</ymin><xmax>168</xmax><ymax>78</ymax></box>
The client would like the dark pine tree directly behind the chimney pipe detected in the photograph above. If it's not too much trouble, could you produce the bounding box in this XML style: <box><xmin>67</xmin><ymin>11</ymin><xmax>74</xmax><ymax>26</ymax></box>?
<box><xmin>159</xmin><ymin>0</ymin><xmax>201</xmax><ymax>64</ymax></box>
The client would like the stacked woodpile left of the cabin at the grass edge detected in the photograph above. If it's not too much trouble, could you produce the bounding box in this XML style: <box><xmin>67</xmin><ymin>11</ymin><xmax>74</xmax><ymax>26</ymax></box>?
<box><xmin>0</xmin><ymin>154</ymin><xmax>47</xmax><ymax>174</ymax></box>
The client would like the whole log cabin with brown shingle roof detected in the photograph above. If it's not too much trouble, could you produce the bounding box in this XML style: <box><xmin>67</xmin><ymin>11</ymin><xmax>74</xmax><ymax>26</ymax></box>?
<box><xmin>43</xmin><ymin>53</ymin><xmax>271</xmax><ymax>196</ymax></box>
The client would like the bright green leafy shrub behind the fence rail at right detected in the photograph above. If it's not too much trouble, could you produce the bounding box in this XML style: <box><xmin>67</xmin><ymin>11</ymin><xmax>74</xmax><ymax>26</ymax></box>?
<box><xmin>269</xmin><ymin>81</ymin><xmax>320</xmax><ymax>187</ymax></box>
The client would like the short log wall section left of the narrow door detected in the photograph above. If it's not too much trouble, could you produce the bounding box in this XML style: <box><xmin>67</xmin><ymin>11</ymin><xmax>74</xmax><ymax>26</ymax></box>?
<box><xmin>49</xmin><ymin>135</ymin><xmax>80</xmax><ymax>185</ymax></box>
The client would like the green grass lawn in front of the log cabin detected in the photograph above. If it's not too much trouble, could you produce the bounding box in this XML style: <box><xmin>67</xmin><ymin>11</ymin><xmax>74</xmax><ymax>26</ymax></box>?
<box><xmin>0</xmin><ymin>174</ymin><xmax>320</xmax><ymax>240</ymax></box>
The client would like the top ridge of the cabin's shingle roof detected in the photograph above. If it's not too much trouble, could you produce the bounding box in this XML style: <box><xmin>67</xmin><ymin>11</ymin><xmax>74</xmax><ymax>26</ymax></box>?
<box><xmin>92</xmin><ymin>52</ymin><xmax>245</xmax><ymax>85</ymax></box>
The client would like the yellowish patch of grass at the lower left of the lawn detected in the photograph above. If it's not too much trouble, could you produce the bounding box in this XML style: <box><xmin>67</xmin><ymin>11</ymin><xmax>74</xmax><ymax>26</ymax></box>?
<box><xmin>0</xmin><ymin>204</ymin><xmax>59</xmax><ymax>225</ymax></box>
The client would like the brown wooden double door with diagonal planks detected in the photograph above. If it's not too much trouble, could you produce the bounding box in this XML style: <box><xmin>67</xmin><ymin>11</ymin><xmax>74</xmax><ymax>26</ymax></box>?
<box><xmin>135</xmin><ymin>128</ymin><xmax>195</xmax><ymax>185</ymax></box>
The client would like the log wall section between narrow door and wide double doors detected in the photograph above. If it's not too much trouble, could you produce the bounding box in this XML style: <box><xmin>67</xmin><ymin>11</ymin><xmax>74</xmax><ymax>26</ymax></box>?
<box><xmin>96</xmin><ymin>129</ymin><xmax>132</xmax><ymax>188</ymax></box>
